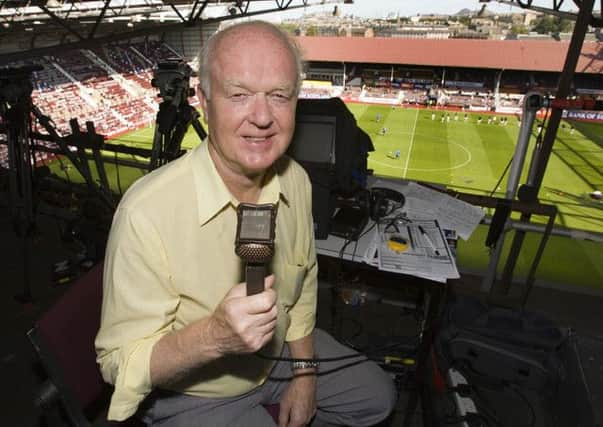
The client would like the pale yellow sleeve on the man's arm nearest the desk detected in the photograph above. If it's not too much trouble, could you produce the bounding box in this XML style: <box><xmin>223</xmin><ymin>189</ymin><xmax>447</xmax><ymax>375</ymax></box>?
<box><xmin>285</xmin><ymin>172</ymin><xmax>318</xmax><ymax>341</ymax></box>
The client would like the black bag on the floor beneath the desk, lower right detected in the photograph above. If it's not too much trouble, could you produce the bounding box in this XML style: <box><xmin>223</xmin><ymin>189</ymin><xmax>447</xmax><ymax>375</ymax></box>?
<box><xmin>436</xmin><ymin>297</ymin><xmax>566</xmax><ymax>391</ymax></box>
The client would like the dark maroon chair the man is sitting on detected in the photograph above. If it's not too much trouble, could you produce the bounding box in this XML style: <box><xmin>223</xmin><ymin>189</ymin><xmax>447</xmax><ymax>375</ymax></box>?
<box><xmin>27</xmin><ymin>262</ymin><xmax>278</xmax><ymax>427</ymax></box>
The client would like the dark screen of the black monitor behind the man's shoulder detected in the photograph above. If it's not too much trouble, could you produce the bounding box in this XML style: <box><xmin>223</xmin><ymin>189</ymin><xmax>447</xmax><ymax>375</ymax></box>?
<box><xmin>287</xmin><ymin>114</ymin><xmax>337</xmax><ymax>165</ymax></box>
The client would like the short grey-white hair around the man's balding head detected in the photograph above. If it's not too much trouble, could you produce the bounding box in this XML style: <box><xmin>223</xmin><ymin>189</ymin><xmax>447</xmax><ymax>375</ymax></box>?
<box><xmin>198</xmin><ymin>20</ymin><xmax>304</xmax><ymax>99</ymax></box>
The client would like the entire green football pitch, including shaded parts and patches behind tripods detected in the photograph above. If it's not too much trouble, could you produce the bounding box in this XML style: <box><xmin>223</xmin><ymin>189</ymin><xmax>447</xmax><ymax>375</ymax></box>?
<box><xmin>52</xmin><ymin>103</ymin><xmax>603</xmax><ymax>293</ymax></box>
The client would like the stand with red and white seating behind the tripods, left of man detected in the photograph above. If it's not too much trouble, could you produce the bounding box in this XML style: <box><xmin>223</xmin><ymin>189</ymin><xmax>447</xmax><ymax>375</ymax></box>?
<box><xmin>0</xmin><ymin>41</ymin><xmax>186</xmax><ymax>169</ymax></box>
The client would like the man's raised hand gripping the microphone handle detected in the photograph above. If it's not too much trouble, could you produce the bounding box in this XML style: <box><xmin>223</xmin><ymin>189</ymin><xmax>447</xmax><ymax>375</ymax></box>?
<box><xmin>210</xmin><ymin>275</ymin><xmax>277</xmax><ymax>355</ymax></box>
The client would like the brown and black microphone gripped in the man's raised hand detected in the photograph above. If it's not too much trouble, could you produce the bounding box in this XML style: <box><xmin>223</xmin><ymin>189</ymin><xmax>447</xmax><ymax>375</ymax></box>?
<box><xmin>235</xmin><ymin>203</ymin><xmax>277</xmax><ymax>295</ymax></box>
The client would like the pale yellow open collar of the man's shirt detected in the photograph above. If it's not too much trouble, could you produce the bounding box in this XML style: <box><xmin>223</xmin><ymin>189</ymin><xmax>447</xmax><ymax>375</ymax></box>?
<box><xmin>191</xmin><ymin>138</ymin><xmax>289</xmax><ymax>225</ymax></box>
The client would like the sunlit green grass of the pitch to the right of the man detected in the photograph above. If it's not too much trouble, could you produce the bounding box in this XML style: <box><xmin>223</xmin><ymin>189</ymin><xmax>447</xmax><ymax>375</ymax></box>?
<box><xmin>349</xmin><ymin>104</ymin><xmax>603</xmax><ymax>232</ymax></box>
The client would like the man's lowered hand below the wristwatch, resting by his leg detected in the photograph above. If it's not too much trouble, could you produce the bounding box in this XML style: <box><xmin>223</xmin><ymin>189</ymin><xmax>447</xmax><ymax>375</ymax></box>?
<box><xmin>278</xmin><ymin>374</ymin><xmax>316</xmax><ymax>427</ymax></box>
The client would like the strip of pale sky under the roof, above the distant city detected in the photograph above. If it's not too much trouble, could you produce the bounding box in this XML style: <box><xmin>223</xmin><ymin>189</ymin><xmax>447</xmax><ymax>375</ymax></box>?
<box><xmin>243</xmin><ymin>0</ymin><xmax>572</xmax><ymax>20</ymax></box>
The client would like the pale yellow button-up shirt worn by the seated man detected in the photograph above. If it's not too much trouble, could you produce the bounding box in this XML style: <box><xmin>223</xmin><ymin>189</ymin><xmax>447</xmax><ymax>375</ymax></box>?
<box><xmin>95</xmin><ymin>142</ymin><xmax>317</xmax><ymax>420</ymax></box>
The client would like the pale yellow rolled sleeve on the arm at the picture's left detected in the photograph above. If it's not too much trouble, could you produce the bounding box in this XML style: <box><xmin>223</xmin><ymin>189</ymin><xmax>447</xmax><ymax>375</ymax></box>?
<box><xmin>95</xmin><ymin>208</ymin><xmax>179</xmax><ymax>420</ymax></box>
